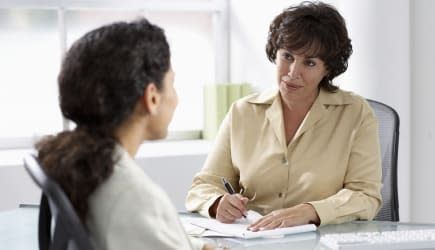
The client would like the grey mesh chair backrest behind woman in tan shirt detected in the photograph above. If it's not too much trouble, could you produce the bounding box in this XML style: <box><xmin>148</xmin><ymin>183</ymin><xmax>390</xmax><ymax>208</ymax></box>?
<box><xmin>367</xmin><ymin>100</ymin><xmax>400</xmax><ymax>221</ymax></box>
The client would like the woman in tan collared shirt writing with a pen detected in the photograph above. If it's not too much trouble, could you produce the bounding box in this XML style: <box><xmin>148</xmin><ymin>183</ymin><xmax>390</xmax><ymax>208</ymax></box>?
<box><xmin>186</xmin><ymin>2</ymin><xmax>381</xmax><ymax>231</ymax></box>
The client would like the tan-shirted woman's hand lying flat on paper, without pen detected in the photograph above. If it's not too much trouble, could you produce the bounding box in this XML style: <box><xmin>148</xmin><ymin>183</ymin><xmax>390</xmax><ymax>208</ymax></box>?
<box><xmin>248</xmin><ymin>203</ymin><xmax>320</xmax><ymax>232</ymax></box>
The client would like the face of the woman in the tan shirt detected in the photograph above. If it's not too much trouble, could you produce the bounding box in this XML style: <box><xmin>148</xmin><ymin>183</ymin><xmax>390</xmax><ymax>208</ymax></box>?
<box><xmin>275</xmin><ymin>49</ymin><xmax>328</xmax><ymax>102</ymax></box>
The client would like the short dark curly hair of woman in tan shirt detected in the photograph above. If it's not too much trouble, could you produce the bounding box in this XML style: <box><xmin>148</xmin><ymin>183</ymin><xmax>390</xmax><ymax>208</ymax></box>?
<box><xmin>266</xmin><ymin>1</ymin><xmax>352</xmax><ymax>92</ymax></box>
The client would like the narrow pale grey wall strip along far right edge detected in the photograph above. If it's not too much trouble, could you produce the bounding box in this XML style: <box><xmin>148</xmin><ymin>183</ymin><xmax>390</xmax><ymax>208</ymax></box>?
<box><xmin>411</xmin><ymin>0</ymin><xmax>435</xmax><ymax>222</ymax></box>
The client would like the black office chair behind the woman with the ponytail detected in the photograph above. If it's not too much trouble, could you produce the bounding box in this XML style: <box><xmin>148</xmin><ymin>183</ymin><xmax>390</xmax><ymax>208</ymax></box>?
<box><xmin>24</xmin><ymin>155</ymin><xmax>94</xmax><ymax>250</ymax></box>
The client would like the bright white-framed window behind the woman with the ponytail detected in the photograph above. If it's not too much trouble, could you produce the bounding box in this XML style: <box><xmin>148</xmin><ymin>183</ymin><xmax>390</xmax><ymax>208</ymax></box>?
<box><xmin>0</xmin><ymin>0</ymin><xmax>228</xmax><ymax>149</ymax></box>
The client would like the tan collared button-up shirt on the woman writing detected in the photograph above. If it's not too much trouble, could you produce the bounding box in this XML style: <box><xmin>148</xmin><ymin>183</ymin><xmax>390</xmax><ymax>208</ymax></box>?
<box><xmin>186</xmin><ymin>87</ymin><xmax>381</xmax><ymax>225</ymax></box>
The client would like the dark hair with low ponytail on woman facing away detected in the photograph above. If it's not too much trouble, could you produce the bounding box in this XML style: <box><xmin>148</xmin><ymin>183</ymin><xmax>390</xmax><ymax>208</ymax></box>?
<box><xmin>36</xmin><ymin>18</ymin><xmax>170</xmax><ymax>221</ymax></box>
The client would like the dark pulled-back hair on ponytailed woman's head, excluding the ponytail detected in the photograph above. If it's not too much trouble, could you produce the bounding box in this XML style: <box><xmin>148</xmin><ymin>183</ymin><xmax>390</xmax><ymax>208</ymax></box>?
<box><xmin>58</xmin><ymin>19</ymin><xmax>170</xmax><ymax>133</ymax></box>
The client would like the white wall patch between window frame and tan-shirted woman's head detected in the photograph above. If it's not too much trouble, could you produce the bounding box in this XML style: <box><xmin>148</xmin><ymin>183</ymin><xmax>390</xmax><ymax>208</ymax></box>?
<box><xmin>229</xmin><ymin>0</ymin><xmax>298</xmax><ymax>90</ymax></box>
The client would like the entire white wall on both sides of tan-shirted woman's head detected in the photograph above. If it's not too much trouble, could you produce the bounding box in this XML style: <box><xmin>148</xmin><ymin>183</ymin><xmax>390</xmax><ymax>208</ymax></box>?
<box><xmin>230</xmin><ymin>0</ymin><xmax>435</xmax><ymax>222</ymax></box>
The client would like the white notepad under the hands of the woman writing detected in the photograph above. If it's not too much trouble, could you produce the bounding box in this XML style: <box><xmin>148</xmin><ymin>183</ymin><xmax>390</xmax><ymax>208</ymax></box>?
<box><xmin>190</xmin><ymin>210</ymin><xmax>317</xmax><ymax>239</ymax></box>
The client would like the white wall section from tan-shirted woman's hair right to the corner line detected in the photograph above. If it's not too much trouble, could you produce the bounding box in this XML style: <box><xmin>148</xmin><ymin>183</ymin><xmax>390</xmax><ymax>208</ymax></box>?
<box><xmin>337</xmin><ymin>0</ymin><xmax>411</xmax><ymax>221</ymax></box>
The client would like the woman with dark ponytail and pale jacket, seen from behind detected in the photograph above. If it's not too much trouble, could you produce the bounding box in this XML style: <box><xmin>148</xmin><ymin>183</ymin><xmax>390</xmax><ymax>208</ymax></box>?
<box><xmin>36</xmin><ymin>19</ymin><xmax>213</xmax><ymax>250</ymax></box>
